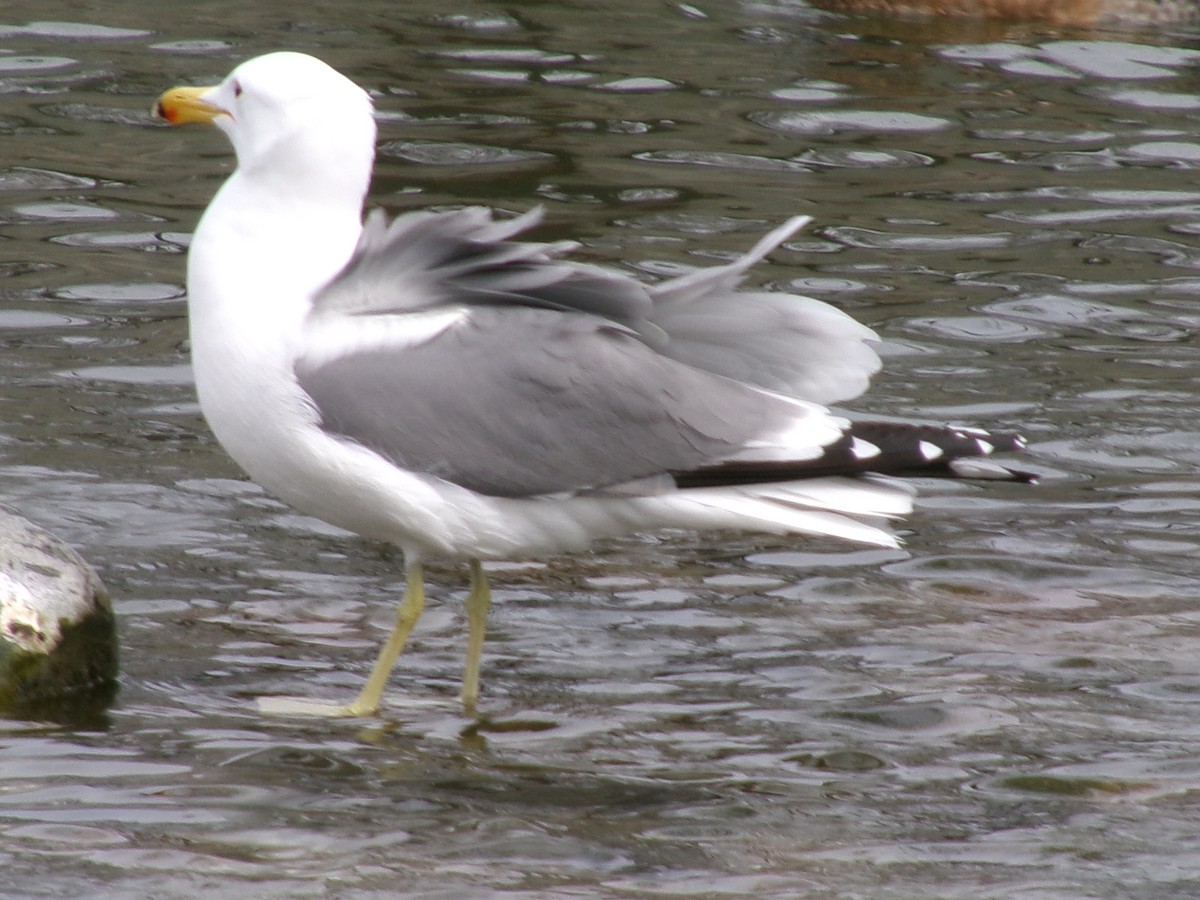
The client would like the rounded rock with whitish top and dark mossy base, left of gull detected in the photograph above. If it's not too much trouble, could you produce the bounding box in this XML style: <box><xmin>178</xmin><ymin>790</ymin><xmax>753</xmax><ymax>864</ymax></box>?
<box><xmin>0</xmin><ymin>508</ymin><xmax>118</xmax><ymax>715</ymax></box>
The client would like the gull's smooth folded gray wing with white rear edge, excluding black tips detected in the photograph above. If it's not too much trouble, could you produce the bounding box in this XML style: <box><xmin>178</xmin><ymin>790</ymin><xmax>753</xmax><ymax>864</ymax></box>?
<box><xmin>295</xmin><ymin>306</ymin><xmax>845</xmax><ymax>497</ymax></box>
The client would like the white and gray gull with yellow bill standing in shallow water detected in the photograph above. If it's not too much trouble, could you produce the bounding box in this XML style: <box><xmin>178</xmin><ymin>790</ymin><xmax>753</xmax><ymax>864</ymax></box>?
<box><xmin>157</xmin><ymin>52</ymin><xmax>1024</xmax><ymax>716</ymax></box>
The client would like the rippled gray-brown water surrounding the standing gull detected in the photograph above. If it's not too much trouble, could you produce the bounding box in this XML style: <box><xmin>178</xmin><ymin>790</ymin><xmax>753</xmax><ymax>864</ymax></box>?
<box><xmin>0</xmin><ymin>0</ymin><xmax>1200</xmax><ymax>898</ymax></box>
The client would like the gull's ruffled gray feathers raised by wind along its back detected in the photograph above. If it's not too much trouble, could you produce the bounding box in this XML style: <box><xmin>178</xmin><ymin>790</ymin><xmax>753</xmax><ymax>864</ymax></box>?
<box><xmin>313</xmin><ymin>208</ymin><xmax>880</xmax><ymax>403</ymax></box>
